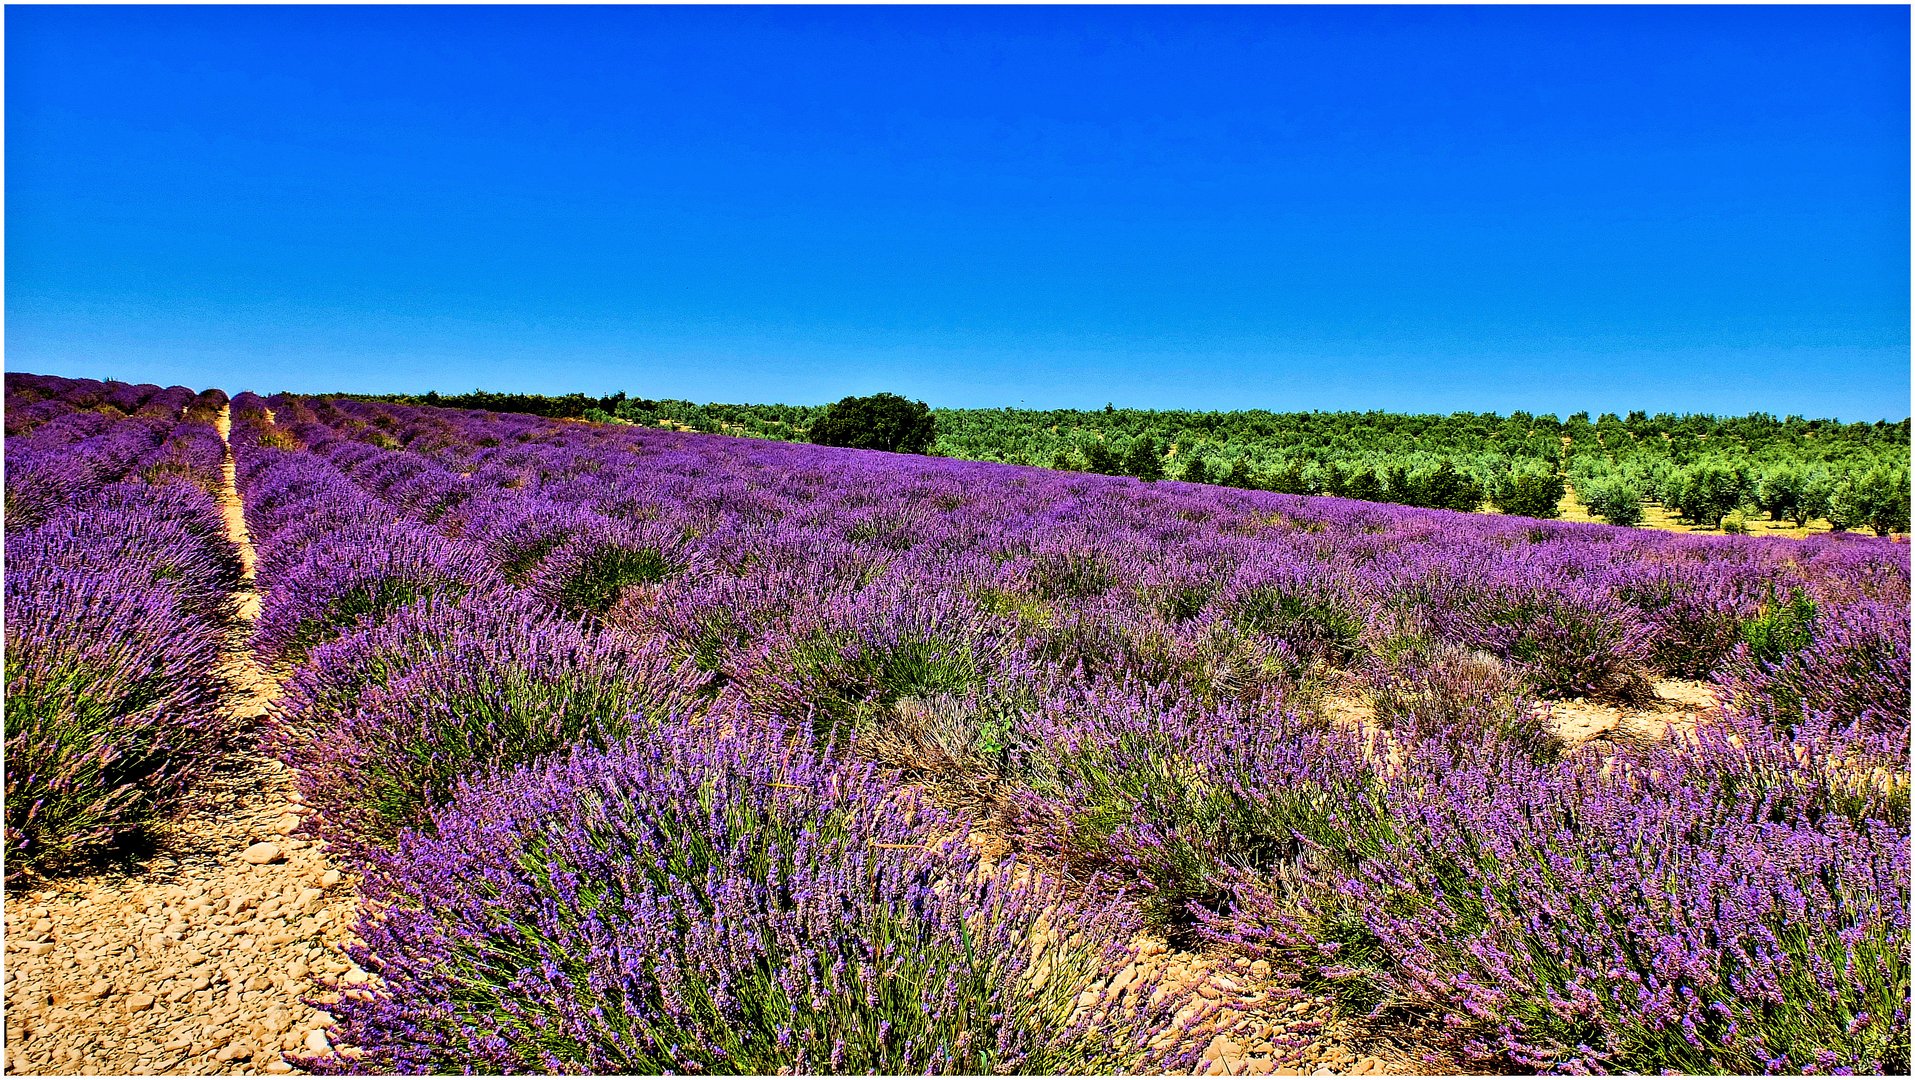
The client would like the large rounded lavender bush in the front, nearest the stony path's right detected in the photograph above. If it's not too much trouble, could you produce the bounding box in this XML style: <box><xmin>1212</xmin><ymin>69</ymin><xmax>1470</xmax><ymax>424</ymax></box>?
<box><xmin>316</xmin><ymin>722</ymin><xmax>1195</xmax><ymax>1074</ymax></box>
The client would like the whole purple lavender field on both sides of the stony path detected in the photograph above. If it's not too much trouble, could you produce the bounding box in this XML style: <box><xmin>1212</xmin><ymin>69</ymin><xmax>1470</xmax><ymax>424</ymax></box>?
<box><xmin>6</xmin><ymin>373</ymin><xmax>1909</xmax><ymax>1074</ymax></box>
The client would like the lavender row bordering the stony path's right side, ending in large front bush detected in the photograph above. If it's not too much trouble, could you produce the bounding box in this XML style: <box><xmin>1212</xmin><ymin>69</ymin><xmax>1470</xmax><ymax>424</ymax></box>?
<box><xmin>234</xmin><ymin>394</ymin><xmax>1199</xmax><ymax>1072</ymax></box>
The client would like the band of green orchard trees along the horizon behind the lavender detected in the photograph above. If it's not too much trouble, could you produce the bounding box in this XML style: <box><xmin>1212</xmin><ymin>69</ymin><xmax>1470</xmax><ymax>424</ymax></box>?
<box><xmin>348</xmin><ymin>391</ymin><xmax>1909</xmax><ymax>532</ymax></box>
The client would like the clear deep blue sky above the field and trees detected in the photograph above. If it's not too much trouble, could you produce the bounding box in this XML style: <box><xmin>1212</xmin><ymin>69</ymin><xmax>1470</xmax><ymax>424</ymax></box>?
<box><xmin>6</xmin><ymin>6</ymin><xmax>1909</xmax><ymax>419</ymax></box>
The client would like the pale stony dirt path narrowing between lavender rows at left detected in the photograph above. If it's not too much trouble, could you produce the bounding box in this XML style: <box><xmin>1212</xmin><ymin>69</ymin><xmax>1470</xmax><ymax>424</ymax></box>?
<box><xmin>6</xmin><ymin>402</ymin><xmax>366</xmax><ymax>1074</ymax></box>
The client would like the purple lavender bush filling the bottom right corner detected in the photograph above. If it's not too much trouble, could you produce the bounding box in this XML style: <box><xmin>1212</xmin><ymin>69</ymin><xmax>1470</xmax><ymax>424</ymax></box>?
<box><xmin>1271</xmin><ymin>747</ymin><xmax>1909</xmax><ymax>1074</ymax></box>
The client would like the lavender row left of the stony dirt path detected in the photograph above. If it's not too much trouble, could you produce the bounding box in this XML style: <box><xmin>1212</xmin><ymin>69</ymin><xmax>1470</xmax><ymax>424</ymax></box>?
<box><xmin>6</xmin><ymin>373</ymin><xmax>239</xmax><ymax>877</ymax></box>
